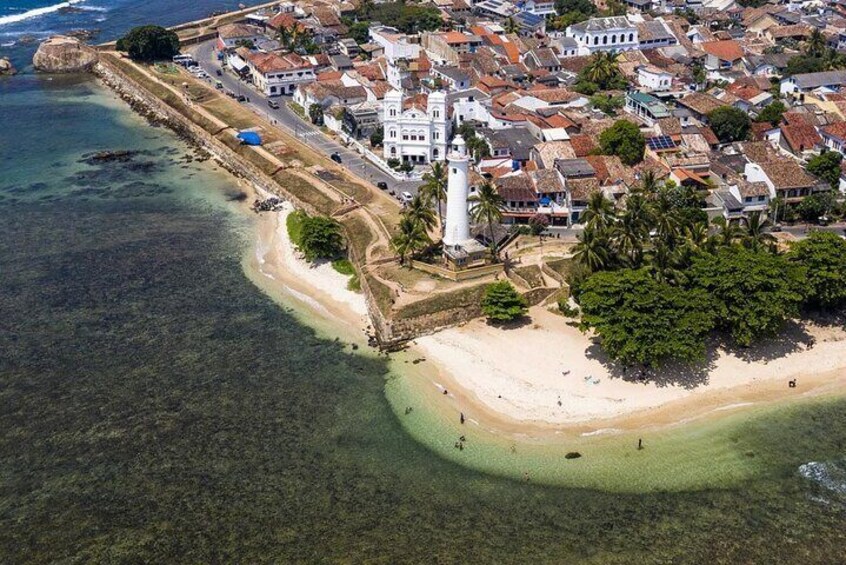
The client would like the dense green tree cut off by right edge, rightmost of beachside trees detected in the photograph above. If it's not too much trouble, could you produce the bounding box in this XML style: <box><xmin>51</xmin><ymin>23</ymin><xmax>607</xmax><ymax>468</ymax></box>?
<box><xmin>788</xmin><ymin>231</ymin><xmax>846</xmax><ymax>308</ymax></box>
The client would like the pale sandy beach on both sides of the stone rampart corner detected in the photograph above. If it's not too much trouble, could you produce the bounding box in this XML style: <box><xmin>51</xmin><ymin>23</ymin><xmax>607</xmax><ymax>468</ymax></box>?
<box><xmin>250</xmin><ymin>204</ymin><xmax>846</xmax><ymax>435</ymax></box>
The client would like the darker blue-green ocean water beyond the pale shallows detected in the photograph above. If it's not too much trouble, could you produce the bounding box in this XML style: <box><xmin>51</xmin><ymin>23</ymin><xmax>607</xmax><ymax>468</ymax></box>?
<box><xmin>0</xmin><ymin>0</ymin><xmax>846</xmax><ymax>564</ymax></box>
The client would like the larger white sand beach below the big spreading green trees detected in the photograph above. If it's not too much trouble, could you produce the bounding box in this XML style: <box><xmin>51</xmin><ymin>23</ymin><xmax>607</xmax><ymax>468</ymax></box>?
<box><xmin>416</xmin><ymin>308</ymin><xmax>846</xmax><ymax>424</ymax></box>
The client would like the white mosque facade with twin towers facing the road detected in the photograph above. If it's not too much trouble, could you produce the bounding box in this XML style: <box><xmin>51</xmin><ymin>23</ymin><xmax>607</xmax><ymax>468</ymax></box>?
<box><xmin>382</xmin><ymin>90</ymin><xmax>449</xmax><ymax>164</ymax></box>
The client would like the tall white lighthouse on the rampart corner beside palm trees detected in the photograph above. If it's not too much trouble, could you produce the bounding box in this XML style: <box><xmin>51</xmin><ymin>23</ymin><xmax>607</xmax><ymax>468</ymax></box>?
<box><xmin>443</xmin><ymin>135</ymin><xmax>487</xmax><ymax>268</ymax></box>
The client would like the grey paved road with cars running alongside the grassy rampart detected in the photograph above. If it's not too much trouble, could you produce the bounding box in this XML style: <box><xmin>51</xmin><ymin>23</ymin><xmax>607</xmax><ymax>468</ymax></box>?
<box><xmin>191</xmin><ymin>41</ymin><xmax>420</xmax><ymax>194</ymax></box>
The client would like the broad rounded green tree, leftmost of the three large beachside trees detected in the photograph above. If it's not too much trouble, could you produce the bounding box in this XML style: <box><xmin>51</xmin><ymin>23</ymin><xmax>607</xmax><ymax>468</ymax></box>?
<box><xmin>579</xmin><ymin>269</ymin><xmax>715</xmax><ymax>366</ymax></box>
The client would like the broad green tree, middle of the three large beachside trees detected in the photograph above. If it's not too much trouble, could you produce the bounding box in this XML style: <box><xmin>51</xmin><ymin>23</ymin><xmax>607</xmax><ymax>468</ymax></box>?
<box><xmin>690</xmin><ymin>246</ymin><xmax>805</xmax><ymax>347</ymax></box>
